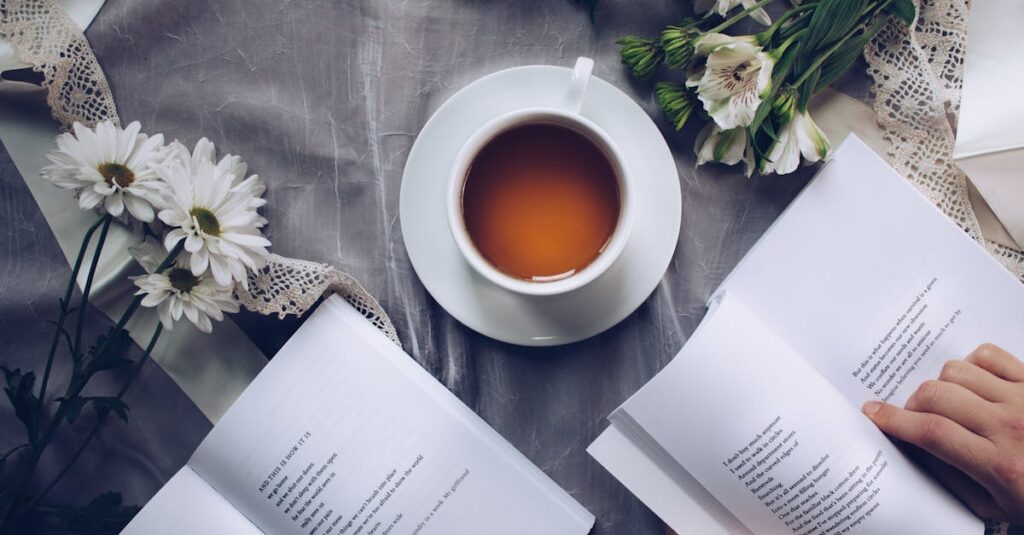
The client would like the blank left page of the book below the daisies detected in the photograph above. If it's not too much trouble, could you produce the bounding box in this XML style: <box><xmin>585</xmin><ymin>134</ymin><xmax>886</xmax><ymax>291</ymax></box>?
<box><xmin>121</xmin><ymin>466</ymin><xmax>263</xmax><ymax>535</ymax></box>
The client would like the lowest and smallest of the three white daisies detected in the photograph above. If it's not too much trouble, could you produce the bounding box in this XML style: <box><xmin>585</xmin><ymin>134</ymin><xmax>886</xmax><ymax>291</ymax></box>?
<box><xmin>129</xmin><ymin>241</ymin><xmax>239</xmax><ymax>333</ymax></box>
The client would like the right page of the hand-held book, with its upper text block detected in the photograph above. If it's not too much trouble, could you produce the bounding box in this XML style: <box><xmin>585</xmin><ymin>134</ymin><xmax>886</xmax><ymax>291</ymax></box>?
<box><xmin>720</xmin><ymin>136</ymin><xmax>1024</xmax><ymax>406</ymax></box>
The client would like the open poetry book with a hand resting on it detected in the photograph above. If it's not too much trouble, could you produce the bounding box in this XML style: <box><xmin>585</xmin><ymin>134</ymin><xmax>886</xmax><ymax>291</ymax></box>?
<box><xmin>589</xmin><ymin>136</ymin><xmax>1024</xmax><ymax>535</ymax></box>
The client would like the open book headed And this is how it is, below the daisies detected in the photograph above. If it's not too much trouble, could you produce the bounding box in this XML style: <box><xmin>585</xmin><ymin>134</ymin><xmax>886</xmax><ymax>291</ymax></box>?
<box><xmin>123</xmin><ymin>296</ymin><xmax>594</xmax><ymax>535</ymax></box>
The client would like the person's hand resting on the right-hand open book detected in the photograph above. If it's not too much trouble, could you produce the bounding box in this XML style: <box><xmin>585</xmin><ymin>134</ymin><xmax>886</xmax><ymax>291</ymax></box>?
<box><xmin>863</xmin><ymin>344</ymin><xmax>1024</xmax><ymax>524</ymax></box>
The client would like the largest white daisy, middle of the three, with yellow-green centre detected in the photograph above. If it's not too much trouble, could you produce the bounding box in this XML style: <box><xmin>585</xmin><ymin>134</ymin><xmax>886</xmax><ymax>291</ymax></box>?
<box><xmin>157</xmin><ymin>139</ymin><xmax>270</xmax><ymax>287</ymax></box>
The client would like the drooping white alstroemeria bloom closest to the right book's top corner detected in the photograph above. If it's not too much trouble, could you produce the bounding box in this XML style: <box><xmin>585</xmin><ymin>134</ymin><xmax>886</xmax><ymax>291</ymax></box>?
<box><xmin>759</xmin><ymin>91</ymin><xmax>831</xmax><ymax>174</ymax></box>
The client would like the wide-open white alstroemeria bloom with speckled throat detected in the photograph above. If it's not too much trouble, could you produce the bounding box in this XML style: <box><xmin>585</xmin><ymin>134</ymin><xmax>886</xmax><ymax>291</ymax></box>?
<box><xmin>686</xmin><ymin>34</ymin><xmax>775</xmax><ymax>130</ymax></box>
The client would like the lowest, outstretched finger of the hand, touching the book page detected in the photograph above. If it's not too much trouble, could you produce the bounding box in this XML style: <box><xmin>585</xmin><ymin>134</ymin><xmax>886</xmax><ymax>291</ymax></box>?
<box><xmin>864</xmin><ymin>402</ymin><xmax>996</xmax><ymax>484</ymax></box>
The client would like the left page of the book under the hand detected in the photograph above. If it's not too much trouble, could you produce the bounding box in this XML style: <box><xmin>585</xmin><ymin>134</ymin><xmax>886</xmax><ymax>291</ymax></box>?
<box><xmin>611</xmin><ymin>294</ymin><xmax>983</xmax><ymax>535</ymax></box>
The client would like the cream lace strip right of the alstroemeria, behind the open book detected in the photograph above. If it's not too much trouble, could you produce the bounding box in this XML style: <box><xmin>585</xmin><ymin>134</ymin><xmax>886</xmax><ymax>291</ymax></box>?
<box><xmin>864</xmin><ymin>0</ymin><xmax>1024</xmax><ymax>280</ymax></box>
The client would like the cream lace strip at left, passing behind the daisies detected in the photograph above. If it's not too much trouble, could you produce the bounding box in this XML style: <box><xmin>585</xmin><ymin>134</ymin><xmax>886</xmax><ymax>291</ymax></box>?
<box><xmin>0</xmin><ymin>0</ymin><xmax>400</xmax><ymax>345</ymax></box>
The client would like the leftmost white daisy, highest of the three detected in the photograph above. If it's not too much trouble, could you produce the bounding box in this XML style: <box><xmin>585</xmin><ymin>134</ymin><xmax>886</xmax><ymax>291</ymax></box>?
<box><xmin>42</xmin><ymin>121</ymin><xmax>167</xmax><ymax>222</ymax></box>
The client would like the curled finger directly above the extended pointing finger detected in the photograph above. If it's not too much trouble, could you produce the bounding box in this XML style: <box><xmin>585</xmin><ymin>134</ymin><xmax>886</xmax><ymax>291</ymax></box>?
<box><xmin>906</xmin><ymin>380</ymin><xmax>999</xmax><ymax>437</ymax></box>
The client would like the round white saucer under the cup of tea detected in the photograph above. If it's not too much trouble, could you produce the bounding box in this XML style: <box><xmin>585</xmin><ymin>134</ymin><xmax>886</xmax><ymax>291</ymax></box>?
<box><xmin>399</xmin><ymin>66</ymin><xmax>682</xmax><ymax>345</ymax></box>
